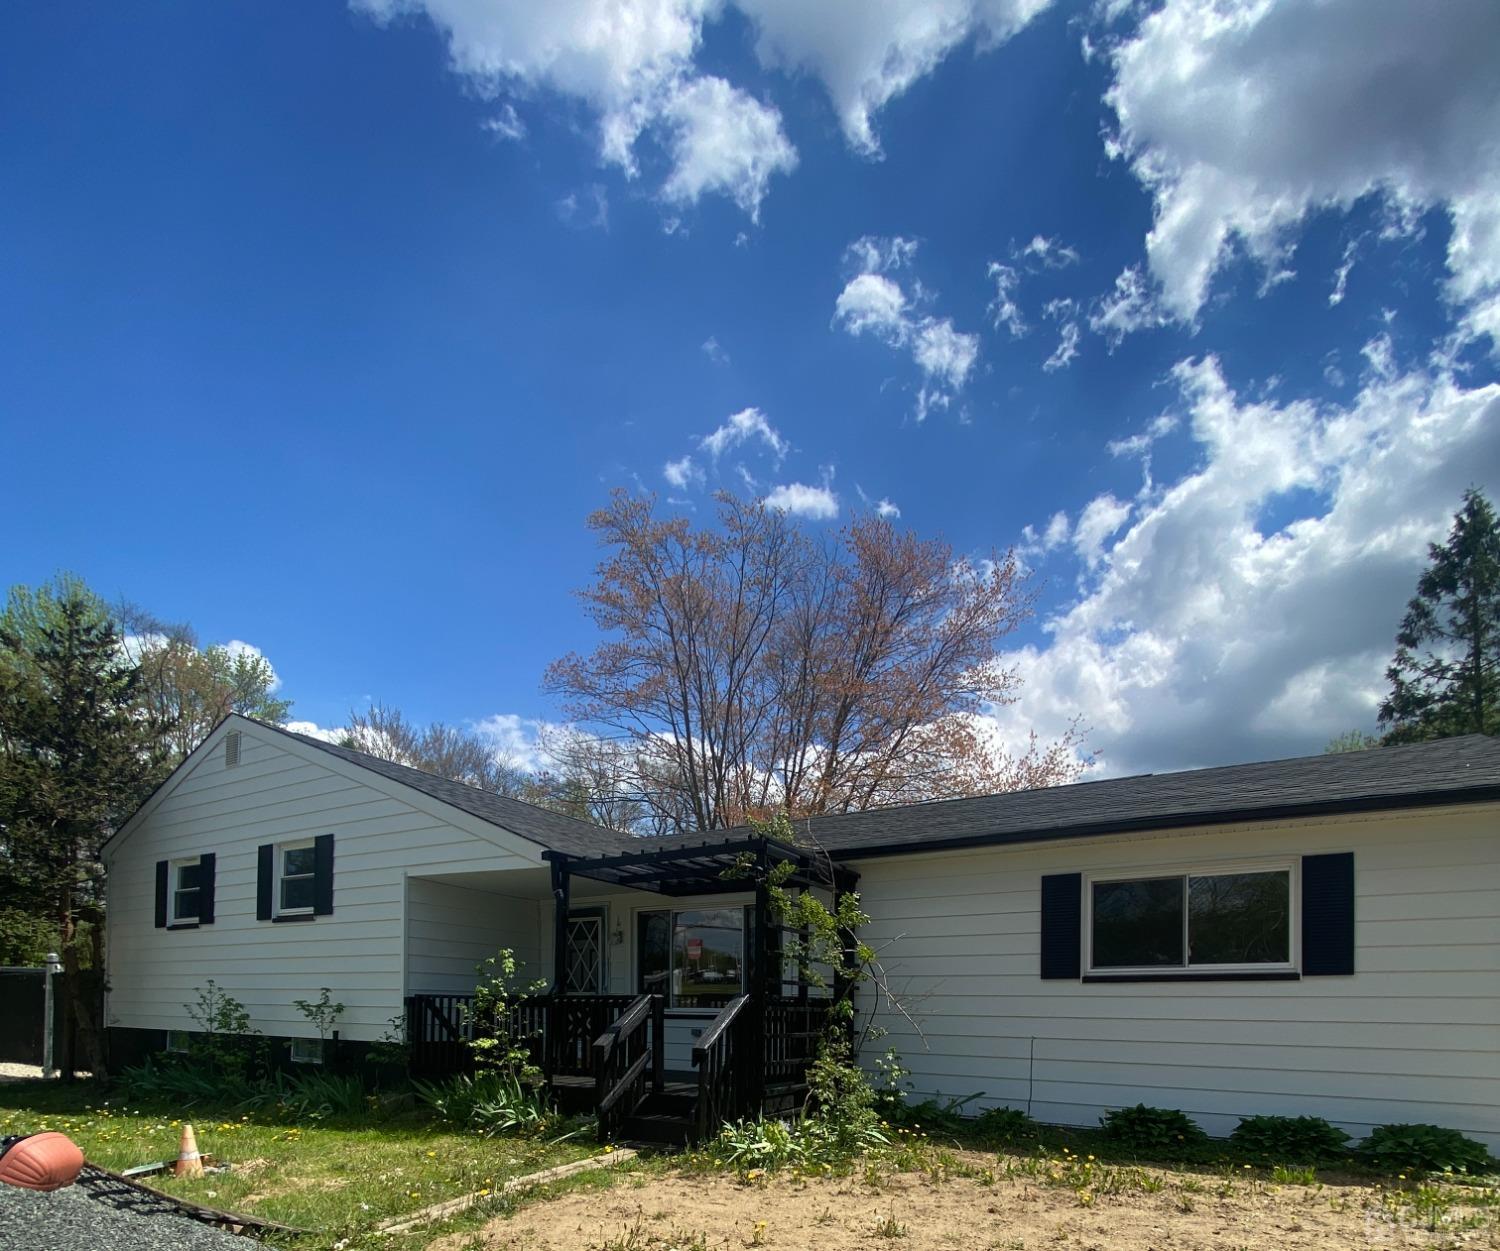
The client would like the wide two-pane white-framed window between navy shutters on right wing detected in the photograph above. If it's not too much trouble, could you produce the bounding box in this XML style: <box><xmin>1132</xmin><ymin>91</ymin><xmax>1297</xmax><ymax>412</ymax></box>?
<box><xmin>1085</xmin><ymin>861</ymin><xmax>1298</xmax><ymax>975</ymax></box>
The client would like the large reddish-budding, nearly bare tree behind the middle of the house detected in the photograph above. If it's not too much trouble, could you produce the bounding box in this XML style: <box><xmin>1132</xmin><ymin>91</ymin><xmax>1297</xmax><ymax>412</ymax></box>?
<box><xmin>546</xmin><ymin>492</ymin><xmax>1080</xmax><ymax>830</ymax></box>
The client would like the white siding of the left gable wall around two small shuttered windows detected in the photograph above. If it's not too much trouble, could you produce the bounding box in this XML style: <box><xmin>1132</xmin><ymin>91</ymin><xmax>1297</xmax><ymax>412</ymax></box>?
<box><xmin>107</xmin><ymin>726</ymin><xmax>540</xmax><ymax>1041</ymax></box>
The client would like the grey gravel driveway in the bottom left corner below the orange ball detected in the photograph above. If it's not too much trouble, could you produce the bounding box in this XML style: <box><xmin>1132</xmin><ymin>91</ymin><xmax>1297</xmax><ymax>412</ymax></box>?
<box><xmin>0</xmin><ymin>1179</ymin><xmax>264</xmax><ymax>1251</ymax></box>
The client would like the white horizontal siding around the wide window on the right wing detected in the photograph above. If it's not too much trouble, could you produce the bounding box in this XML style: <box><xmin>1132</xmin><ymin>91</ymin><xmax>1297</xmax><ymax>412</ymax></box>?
<box><xmin>855</xmin><ymin>807</ymin><xmax>1500</xmax><ymax>1145</ymax></box>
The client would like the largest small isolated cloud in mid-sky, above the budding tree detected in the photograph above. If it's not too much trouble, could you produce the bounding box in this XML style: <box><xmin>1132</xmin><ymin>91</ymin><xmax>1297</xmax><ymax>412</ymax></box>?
<box><xmin>834</xmin><ymin>236</ymin><xmax>980</xmax><ymax>420</ymax></box>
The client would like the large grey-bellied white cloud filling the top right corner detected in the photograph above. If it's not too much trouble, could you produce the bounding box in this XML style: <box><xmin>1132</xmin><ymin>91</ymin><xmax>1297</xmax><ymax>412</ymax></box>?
<box><xmin>1106</xmin><ymin>0</ymin><xmax>1500</xmax><ymax>343</ymax></box>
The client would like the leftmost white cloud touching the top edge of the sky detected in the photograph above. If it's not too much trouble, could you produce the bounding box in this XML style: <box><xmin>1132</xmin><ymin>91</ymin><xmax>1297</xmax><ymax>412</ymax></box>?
<box><xmin>351</xmin><ymin>0</ymin><xmax>797</xmax><ymax>218</ymax></box>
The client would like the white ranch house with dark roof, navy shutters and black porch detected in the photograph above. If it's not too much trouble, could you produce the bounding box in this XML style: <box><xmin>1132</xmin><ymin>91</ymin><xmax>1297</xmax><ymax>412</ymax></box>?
<box><xmin>105</xmin><ymin>717</ymin><xmax>1500</xmax><ymax>1146</ymax></box>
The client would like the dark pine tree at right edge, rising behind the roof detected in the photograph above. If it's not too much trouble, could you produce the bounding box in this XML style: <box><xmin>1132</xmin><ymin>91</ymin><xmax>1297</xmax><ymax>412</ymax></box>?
<box><xmin>1380</xmin><ymin>488</ymin><xmax>1500</xmax><ymax>743</ymax></box>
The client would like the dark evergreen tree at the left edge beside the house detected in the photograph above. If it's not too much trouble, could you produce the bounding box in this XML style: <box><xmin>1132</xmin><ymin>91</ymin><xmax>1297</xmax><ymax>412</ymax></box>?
<box><xmin>0</xmin><ymin>578</ymin><xmax>165</xmax><ymax>1074</ymax></box>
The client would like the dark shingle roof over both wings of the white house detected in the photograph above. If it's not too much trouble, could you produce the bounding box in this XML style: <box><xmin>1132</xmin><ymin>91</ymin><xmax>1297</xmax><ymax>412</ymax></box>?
<box><xmin>269</xmin><ymin>726</ymin><xmax>1500</xmax><ymax>857</ymax></box>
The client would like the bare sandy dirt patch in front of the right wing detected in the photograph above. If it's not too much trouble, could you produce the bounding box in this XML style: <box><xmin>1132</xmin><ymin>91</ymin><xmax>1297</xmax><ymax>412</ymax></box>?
<box><xmin>429</xmin><ymin>1155</ymin><xmax>1500</xmax><ymax>1251</ymax></box>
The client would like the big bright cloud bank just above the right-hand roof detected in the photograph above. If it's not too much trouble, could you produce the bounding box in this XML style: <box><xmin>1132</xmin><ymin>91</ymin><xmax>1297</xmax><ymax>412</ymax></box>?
<box><xmin>995</xmin><ymin>357</ymin><xmax>1500</xmax><ymax>773</ymax></box>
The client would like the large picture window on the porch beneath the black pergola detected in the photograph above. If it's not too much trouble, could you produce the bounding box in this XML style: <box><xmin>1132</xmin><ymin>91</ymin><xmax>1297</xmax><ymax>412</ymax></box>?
<box><xmin>638</xmin><ymin>908</ymin><xmax>750</xmax><ymax>1008</ymax></box>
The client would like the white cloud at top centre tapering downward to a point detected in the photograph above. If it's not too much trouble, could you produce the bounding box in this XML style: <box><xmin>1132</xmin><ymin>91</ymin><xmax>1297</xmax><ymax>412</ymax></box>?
<box><xmin>735</xmin><ymin>0</ymin><xmax>1050</xmax><ymax>156</ymax></box>
